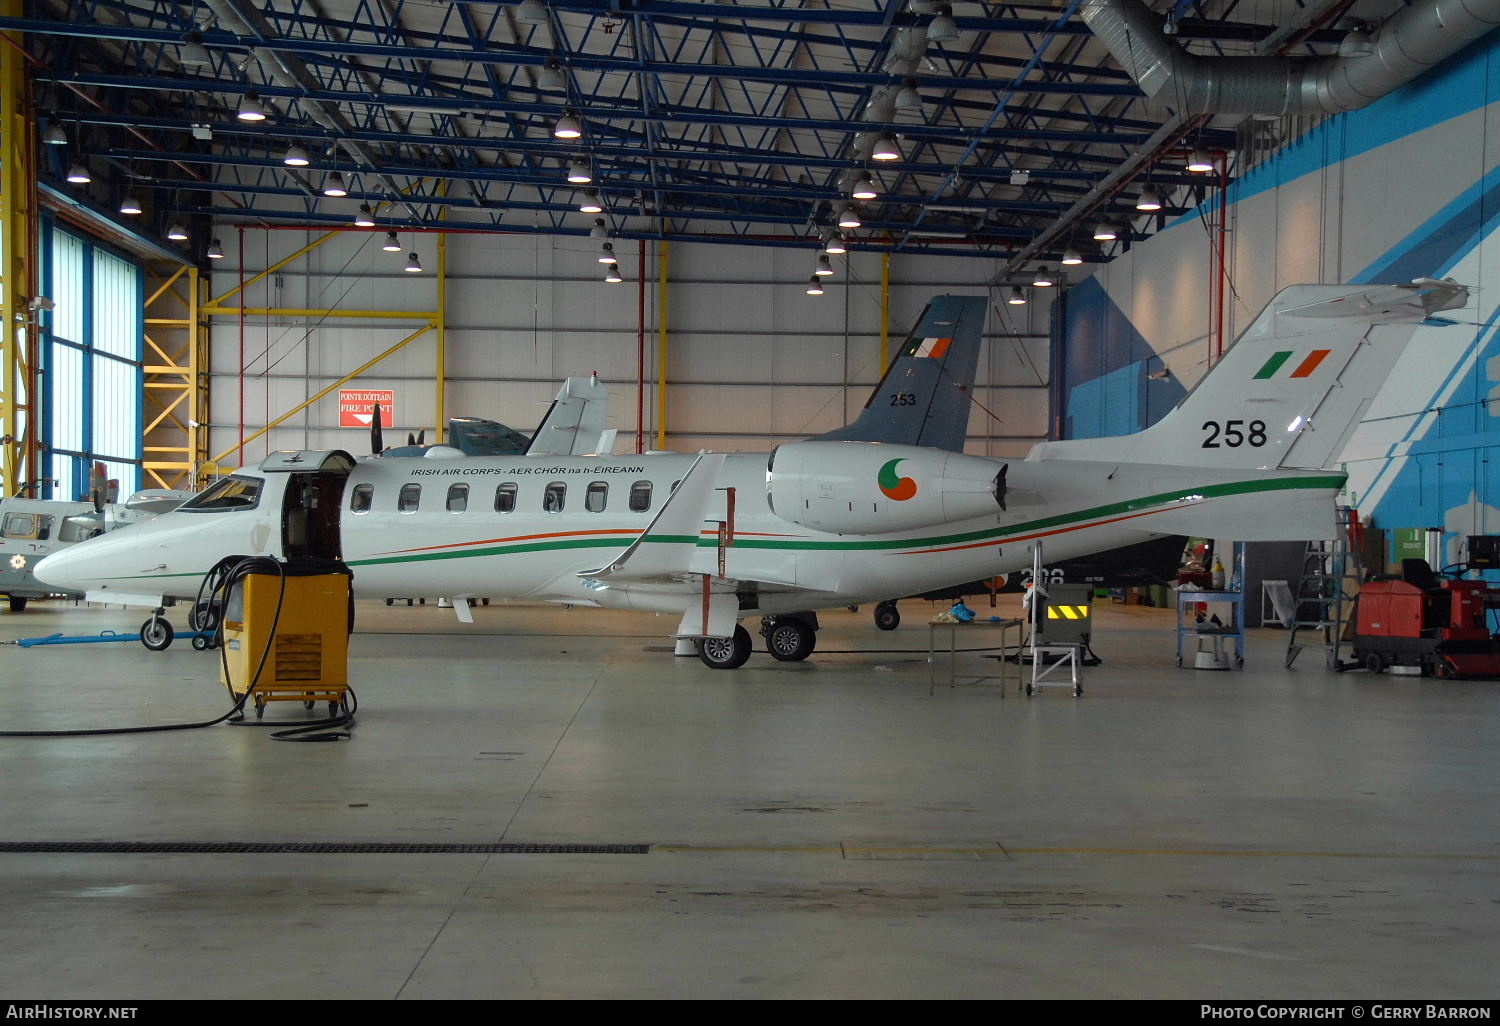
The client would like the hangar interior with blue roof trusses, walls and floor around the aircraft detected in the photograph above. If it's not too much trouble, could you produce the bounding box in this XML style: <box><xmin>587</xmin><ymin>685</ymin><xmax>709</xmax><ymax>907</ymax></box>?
<box><xmin>0</xmin><ymin>0</ymin><xmax>1500</xmax><ymax>999</ymax></box>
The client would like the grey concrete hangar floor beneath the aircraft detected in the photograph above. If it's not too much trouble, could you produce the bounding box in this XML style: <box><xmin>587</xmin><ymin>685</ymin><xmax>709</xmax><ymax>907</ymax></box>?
<box><xmin>0</xmin><ymin>603</ymin><xmax>1500</xmax><ymax>999</ymax></box>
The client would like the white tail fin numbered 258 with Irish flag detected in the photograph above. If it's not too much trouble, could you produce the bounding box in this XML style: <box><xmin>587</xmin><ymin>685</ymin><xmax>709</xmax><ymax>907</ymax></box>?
<box><xmin>1028</xmin><ymin>278</ymin><xmax>1469</xmax><ymax>470</ymax></box>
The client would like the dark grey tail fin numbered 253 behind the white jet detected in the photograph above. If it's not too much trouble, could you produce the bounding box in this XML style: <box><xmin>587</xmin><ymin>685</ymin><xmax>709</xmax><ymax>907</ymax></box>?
<box><xmin>818</xmin><ymin>288</ymin><xmax>989</xmax><ymax>453</ymax></box>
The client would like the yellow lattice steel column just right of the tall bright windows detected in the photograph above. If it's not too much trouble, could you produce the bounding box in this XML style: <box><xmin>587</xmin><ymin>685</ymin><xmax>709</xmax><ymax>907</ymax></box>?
<box><xmin>141</xmin><ymin>267</ymin><xmax>209</xmax><ymax>489</ymax></box>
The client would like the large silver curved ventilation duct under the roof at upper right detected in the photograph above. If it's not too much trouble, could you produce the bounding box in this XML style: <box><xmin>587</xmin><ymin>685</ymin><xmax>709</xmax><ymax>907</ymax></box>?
<box><xmin>1080</xmin><ymin>0</ymin><xmax>1500</xmax><ymax>114</ymax></box>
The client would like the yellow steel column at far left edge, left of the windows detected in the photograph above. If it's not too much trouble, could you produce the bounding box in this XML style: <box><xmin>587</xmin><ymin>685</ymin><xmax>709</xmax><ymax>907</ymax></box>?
<box><xmin>0</xmin><ymin>0</ymin><xmax>36</xmax><ymax>495</ymax></box>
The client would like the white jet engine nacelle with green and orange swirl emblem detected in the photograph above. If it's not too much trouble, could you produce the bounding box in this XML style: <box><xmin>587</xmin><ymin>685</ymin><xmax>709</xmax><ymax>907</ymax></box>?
<box><xmin>767</xmin><ymin>441</ymin><xmax>1005</xmax><ymax>534</ymax></box>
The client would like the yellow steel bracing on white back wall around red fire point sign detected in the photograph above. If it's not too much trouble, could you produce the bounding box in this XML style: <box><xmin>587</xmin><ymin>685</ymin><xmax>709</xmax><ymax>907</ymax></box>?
<box><xmin>202</xmin><ymin>225</ymin><xmax>447</xmax><ymax>477</ymax></box>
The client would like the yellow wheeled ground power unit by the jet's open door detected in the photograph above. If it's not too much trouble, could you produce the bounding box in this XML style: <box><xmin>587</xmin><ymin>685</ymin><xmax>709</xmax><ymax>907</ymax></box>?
<box><xmin>222</xmin><ymin>560</ymin><xmax>354</xmax><ymax>717</ymax></box>
